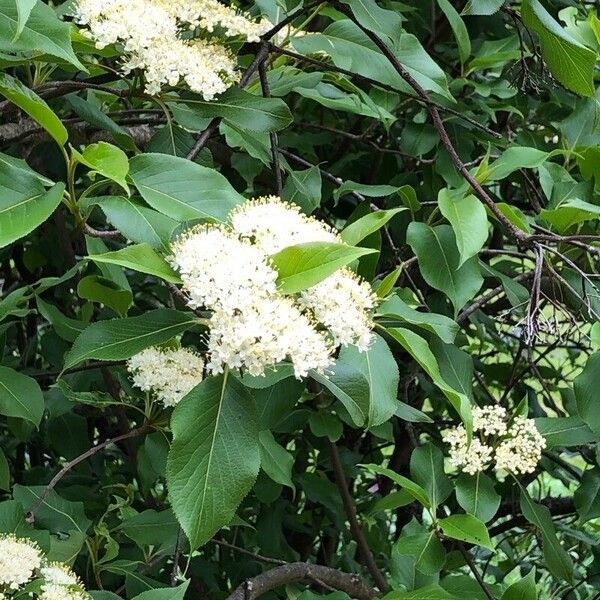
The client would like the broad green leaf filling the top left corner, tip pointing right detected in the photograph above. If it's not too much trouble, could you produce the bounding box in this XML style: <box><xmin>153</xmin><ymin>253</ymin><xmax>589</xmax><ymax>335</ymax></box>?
<box><xmin>0</xmin><ymin>0</ymin><xmax>87</xmax><ymax>72</ymax></box>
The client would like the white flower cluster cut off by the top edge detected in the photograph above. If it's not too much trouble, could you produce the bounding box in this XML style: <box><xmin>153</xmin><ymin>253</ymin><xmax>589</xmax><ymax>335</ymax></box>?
<box><xmin>76</xmin><ymin>0</ymin><xmax>269</xmax><ymax>101</ymax></box>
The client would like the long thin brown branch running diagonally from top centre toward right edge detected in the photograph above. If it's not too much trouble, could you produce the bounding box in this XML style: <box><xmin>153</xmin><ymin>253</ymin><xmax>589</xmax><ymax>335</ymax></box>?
<box><xmin>335</xmin><ymin>2</ymin><xmax>529</xmax><ymax>243</ymax></box>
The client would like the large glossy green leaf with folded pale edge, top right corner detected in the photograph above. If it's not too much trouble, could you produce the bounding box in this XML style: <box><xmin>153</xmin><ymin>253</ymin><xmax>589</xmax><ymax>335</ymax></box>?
<box><xmin>521</xmin><ymin>0</ymin><xmax>597</xmax><ymax>96</ymax></box>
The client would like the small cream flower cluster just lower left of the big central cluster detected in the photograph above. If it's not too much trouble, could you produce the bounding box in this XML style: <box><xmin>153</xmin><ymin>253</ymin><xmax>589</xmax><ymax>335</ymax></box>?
<box><xmin>127</xmin><ymin>347</ymin><xmax>204</xmax><ymax>407</ymax></box>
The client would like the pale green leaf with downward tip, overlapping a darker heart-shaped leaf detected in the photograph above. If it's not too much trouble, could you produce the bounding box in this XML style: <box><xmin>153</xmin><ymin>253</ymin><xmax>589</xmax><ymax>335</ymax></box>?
<box><xmin>438</xmin><ymin>189</ymin><xmax>488</xmax><ymax>268</ymax></box>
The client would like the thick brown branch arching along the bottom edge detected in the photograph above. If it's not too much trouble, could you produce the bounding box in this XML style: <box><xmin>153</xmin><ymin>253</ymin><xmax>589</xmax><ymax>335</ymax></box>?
<box><xmin>227</xmin><ymin>562</ymin><xmax>376</xmax><ymax>600</ymax></box>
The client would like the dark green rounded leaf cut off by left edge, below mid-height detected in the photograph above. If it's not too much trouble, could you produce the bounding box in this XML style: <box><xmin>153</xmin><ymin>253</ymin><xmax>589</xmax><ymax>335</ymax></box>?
<box><xmin>0</xmin><ymin>366</ymin><xmax>44</xmax><ymax>427</ymax></box>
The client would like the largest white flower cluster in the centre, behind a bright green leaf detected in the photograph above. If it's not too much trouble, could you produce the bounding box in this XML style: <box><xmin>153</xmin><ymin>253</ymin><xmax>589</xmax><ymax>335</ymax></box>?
<box><xmin>172</xmin><ymin>197</ymin><xmax>374</xmax><ymax>378</ymax></box>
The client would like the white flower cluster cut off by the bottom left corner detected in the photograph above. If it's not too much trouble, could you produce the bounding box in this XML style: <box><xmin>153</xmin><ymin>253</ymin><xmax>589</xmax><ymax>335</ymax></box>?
<box><xmin>0</xmin><ymin>535</ymin><xmax>90</xmax><ymax>600</ymax></box>
